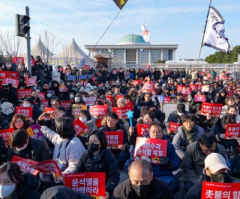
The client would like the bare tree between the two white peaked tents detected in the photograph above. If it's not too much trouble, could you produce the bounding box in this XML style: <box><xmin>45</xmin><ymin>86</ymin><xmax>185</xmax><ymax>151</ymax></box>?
<box><xmin>39</xmin><ymin>30</ymin><xmax>60</xmax><ymax>62</ymax></box>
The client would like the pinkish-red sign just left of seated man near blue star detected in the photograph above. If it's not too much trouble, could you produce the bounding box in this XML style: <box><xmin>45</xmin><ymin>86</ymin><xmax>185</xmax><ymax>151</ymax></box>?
<box><xmin>90</xmin><ymin>104</ymin><xmax>108</xmax><ymax>127</ymax></box>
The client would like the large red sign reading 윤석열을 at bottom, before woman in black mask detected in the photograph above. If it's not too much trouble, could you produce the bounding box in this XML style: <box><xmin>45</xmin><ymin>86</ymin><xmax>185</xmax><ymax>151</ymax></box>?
<box><xmin>64</xmin><ymin>172</ymin><xmax>106</xmax><ymax>199</ymax></box>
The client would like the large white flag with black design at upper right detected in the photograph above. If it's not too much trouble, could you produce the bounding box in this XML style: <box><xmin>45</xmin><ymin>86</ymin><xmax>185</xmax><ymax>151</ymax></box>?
<box><xmin>202</xmin><ymin>6</ymin><xmax>230</xmax><ymax>53</ymax></box>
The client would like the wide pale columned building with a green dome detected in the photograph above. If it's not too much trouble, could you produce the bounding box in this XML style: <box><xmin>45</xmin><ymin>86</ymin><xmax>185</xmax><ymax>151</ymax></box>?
<box><xmin>85</xmin><ymin>34</ymin><xmax>178</xmax><ymax>68</ymax></box>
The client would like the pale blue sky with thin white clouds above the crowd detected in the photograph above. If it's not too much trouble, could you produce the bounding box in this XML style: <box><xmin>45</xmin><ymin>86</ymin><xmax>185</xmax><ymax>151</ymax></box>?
<box><xmin>0</xmin><ymin>0</ymin><xmax>240</xmax><ymax>59</ymax></box>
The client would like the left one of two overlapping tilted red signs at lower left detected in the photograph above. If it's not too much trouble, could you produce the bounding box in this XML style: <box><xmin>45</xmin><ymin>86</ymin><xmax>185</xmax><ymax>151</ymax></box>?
<box><xmin>12</xmin><ymin>155</ymin><xmax>39</xmax><ymax>176</ymax></box>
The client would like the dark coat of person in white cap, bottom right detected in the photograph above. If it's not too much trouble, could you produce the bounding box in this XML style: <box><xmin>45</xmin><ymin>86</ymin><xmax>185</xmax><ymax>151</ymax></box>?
<box><xmin>185</xmin><ymin>175</ymin><xmax>233</xmax><ymax>199</ymax></box>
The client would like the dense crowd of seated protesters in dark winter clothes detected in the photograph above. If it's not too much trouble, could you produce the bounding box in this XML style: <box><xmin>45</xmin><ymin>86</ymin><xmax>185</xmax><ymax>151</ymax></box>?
<box><xmin>0</xmin><ymin>56</ymin><xmax>240</xmax><ymax>199</ymax></box>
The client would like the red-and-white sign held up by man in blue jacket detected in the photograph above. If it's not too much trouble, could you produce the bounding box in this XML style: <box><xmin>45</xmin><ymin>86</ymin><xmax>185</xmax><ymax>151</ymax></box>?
<box><xmin>134</xmin><ymin>137</ymin><xmax>167</xmax><ymax>164</ymax></box>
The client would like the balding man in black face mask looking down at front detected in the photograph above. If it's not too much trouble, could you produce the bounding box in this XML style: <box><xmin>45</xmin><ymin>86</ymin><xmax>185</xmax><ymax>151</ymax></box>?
<box><xmin>113</xmin><ymin>160</ymin><xmax>173</xmax><ymax>199</ymax></box>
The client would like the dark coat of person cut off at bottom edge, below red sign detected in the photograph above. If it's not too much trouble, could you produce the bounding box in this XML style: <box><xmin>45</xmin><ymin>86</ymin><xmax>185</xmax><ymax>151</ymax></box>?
<box><xmin>41</xmin><ymin>185</ymin><xmax>92</xmax><ymax>199</ymax></box>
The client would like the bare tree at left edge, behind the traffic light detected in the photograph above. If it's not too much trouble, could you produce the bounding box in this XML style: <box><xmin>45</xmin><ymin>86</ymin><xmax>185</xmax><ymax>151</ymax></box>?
<box><xmin>0</xmin><ymin>30</ymin><xmax>24</xmax><ymax>60</ymax></box>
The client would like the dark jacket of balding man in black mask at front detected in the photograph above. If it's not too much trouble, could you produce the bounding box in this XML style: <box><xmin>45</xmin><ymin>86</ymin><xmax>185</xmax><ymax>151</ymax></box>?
<box><xmin>113</xmin><ymin>177</ymin><xmax>174</xmax><ymax>199</ymax></box>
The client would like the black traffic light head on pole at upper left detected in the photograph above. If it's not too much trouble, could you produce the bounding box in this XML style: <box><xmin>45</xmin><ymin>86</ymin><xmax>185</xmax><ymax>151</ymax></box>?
<box><xmin>15</xmin><ymin>14</ymin><xmax>30</xmax><ymax>37</ymax></box>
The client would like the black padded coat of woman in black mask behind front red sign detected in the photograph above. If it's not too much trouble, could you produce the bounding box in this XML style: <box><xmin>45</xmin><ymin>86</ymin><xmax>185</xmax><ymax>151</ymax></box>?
<box><xmin>74</xmin><ymin>149</ymin><xmax>120</xmax><ymax>194</ymax></box>
